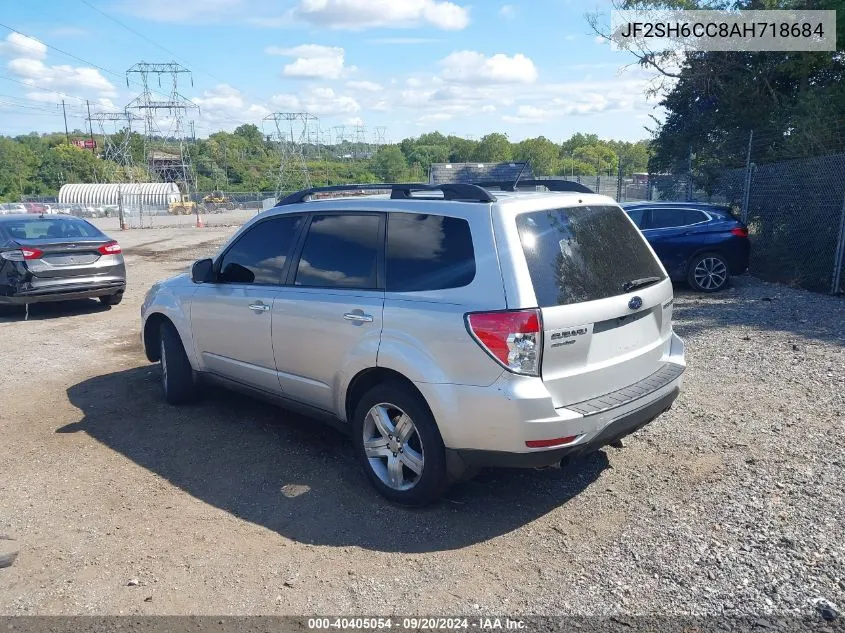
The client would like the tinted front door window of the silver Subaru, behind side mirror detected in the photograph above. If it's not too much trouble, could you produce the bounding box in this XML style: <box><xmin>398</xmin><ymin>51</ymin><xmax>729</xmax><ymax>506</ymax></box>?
<box><xmin>218</xmin><ymin>215</ymin><xmax>302</xmax><ymax>284</ymax></box>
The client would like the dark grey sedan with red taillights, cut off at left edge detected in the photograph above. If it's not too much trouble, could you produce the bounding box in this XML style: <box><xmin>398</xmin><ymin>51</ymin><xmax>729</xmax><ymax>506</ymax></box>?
<box><xmin>0</xmin><ymin>214</ymin><xmax>126</xmax><ymax>306</ymax></box>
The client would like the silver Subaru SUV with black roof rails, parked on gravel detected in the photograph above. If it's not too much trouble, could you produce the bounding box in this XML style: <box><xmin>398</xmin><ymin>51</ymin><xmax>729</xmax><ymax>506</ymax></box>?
<box><xmin>141</xmin><ymin>183</ymin><xmax>685</xmax><ymax>505</ymax></box>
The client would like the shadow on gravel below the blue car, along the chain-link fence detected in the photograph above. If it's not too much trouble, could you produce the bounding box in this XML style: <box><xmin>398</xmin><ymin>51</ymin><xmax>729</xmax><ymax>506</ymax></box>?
<box><xmin>673</xmin><ymin>275</ymin><xmax>845</xmax><ymax>346</ymax></box>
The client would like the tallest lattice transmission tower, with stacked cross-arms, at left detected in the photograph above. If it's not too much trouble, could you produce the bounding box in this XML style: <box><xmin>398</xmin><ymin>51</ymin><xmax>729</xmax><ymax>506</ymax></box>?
<box><xmin>126</xmin><ymin>62</ymin><xmax>199</xmax><ymax>195</ymax></box>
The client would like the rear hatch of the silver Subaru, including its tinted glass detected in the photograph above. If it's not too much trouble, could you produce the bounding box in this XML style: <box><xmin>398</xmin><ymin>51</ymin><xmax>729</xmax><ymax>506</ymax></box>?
<box><xmin>516</xmin><ymin>204</ymin><xmax>672</xmax><ymax>407</ymax></box>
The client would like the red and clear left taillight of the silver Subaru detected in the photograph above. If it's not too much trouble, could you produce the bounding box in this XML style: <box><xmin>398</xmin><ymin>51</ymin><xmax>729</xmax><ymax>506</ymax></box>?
<box><xmin>466</xmin><ymin>310</ymin><xmax>543</xmax><ymax>376</ymax></box>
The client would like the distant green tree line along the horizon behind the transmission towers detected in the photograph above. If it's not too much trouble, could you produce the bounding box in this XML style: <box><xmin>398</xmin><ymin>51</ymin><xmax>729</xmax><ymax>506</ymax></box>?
<box><xmin>0</xmin><ymin>124</ymin><xmax>650</xmax><ymax>201</ymax></box>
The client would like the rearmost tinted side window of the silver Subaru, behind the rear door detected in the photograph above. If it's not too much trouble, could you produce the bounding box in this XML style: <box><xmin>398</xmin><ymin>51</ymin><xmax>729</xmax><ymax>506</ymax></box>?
<box><xmin>387</xmin><ymin>213</ymin><xmax>475</xmax><ymax>292</ymax></box>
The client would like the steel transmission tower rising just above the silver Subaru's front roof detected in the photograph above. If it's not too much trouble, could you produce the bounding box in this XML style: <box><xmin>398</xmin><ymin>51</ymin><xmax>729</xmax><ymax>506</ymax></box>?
<box><xmin>264</xmin><ymin>112</ymin><xmax>320</xmax><ymax>198</ymax></box>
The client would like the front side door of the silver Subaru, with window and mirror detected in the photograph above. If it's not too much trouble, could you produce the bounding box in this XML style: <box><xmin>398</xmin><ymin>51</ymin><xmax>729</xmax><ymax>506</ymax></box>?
<box><xmin>191</xmin><ymin>215</ymin><xmax>304</xmax><ymax>394</ymax></box>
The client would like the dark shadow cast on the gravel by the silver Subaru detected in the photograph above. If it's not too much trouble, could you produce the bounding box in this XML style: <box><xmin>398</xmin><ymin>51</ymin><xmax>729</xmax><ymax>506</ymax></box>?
<box><xmin>57</xmin><ymin>365</ymin><xmax>608</xmax><ymax>552</ymax></box>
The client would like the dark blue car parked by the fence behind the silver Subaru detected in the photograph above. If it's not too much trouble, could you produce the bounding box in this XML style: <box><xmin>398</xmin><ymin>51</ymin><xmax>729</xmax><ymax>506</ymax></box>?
<box><xmin>622</xmin><ymin>202</ymin><xmax>751</xmax><ymax>292</ymax></box>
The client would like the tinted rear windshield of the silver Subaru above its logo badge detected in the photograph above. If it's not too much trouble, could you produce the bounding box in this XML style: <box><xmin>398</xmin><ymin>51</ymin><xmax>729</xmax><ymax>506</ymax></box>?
<box><xmin>516</xmin><ymin>206</ymin><xmax>665</xmax><ymax>308</ymax></box>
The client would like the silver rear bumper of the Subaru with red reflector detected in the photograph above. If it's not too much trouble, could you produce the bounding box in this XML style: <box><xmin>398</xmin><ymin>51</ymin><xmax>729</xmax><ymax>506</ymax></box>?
<box><xmin>417</xmin><ymin>334</ymin><xmax>686</xmax><ymax>466</ymax></box>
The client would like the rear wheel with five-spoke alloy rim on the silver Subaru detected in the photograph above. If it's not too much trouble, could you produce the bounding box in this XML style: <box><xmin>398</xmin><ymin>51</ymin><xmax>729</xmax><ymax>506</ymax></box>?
<box><xmin>353</xmin><ymin>383</ymin><xmax>449</xmax><ymax>506</ymax></box>
